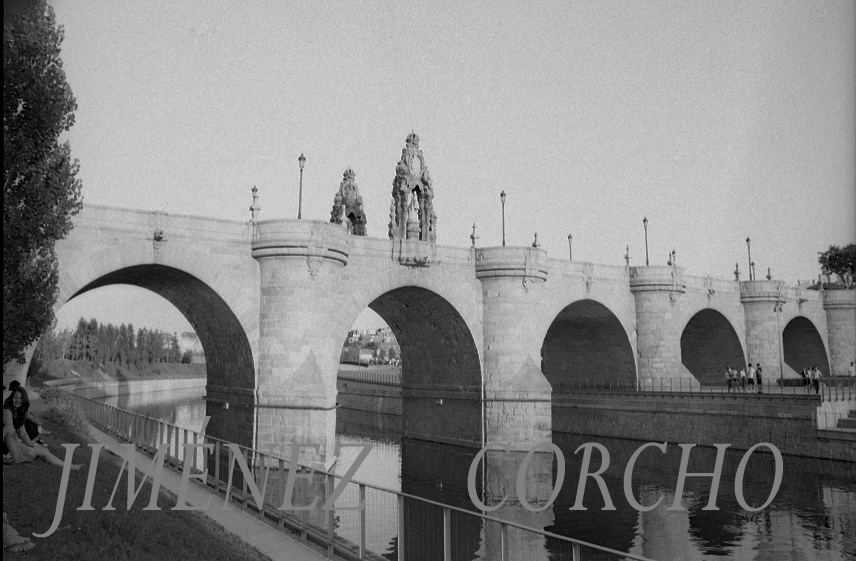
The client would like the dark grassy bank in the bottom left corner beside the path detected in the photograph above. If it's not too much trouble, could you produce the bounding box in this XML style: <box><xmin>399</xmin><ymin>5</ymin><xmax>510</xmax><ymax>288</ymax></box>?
<box><xmin>3</xmin><ymin>392</ymin><xmax>269</xmax><ymax>561</ymax></box>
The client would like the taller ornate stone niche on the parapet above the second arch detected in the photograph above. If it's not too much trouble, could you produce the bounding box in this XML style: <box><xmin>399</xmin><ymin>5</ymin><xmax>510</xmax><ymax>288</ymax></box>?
<box><xmin>389</xmin><ymin>133</ymin><xmax>437</xmax><ymax>243</ymax></box>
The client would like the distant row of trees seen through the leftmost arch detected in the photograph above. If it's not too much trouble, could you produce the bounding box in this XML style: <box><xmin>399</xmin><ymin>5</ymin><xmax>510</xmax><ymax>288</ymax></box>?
<box><xmin>39</xmin><ymin>318</ymin><xmax>192</xmax><ymax>366</ymax></box>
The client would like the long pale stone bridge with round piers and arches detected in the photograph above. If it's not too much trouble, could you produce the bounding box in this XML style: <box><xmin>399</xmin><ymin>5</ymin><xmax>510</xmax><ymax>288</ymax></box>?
<box><xmin>10</xmin><ymin>205</ymin><xmax>856</xmax><ymax>462</ymax></box>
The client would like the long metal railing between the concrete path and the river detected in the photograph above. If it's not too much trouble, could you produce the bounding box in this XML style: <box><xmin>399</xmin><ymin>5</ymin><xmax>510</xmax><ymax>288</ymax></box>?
<box><xmin>72</xmin><ymin>394</ymin><xmax>650</xmax><ymax>561</ymax></box>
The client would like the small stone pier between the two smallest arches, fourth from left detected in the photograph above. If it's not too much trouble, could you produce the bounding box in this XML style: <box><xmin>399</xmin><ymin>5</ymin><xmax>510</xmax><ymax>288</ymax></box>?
<box><xmin>740</xmin><ymin>280</ymin><xmax>786</xmax><ymax>383</ymax></box>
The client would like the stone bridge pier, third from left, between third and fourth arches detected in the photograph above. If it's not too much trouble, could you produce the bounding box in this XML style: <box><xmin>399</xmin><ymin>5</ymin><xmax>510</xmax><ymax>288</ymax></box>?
<box><xmin>630</xmin><ymin>267</ymin><xmax>699</xmax><ymax>390</ymax></box>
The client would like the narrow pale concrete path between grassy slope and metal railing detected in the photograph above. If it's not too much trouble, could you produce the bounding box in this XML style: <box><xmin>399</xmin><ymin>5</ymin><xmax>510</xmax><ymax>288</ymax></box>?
<box><xmin>89</xmin><ymin>425</ymin><xmax>327</xmax><ymax>561</ymax></box>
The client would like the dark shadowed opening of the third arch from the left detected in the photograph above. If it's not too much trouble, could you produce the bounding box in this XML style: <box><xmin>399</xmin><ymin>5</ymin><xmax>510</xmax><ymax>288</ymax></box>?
<box><xmin>541</xmin><ymin>299</ymin><xmax>636</xmax><ymax>395</ymax></box>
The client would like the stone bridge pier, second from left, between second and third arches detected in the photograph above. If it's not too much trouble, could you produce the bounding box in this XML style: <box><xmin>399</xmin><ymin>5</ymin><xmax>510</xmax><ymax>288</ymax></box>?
<box><xmin>476</xmin><ymin>247</ymin><xmax>552</xmax><ymax>450</ymax></box>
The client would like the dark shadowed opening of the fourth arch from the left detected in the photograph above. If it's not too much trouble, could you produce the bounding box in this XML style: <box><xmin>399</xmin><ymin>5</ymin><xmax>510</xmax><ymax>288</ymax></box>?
<box><xmin>681</xmin><ymin>308</ymin><xmax>746</xmax><ymax>386</ymax></box>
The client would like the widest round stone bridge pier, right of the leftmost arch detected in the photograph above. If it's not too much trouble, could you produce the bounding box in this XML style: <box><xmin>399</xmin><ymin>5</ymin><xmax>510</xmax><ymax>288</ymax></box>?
<box><xmin>252</xmin><ymin>221</ymin><xmax>348</xmax><ymax>463</ymax></box>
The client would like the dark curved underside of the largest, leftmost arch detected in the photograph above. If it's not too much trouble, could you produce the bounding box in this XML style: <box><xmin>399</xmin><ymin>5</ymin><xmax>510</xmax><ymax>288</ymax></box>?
<box><xmin>68</xmin><ymin>264</ymin><xmax>256</xmax><ymax>445</ymax></box>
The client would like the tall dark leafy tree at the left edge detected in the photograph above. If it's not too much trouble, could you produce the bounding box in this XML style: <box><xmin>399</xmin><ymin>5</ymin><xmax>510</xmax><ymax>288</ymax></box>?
<box><xmin>3</xmin><ymin>0</ymin><xmax>81</xmax><ymax>364</ymax></box>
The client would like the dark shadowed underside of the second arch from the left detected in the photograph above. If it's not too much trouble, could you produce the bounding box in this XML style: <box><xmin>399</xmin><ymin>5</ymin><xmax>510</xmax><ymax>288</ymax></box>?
<box><xmin>368</xmin><ymin>286</ymin><xmax>482</xmax><ymax>447</ymax></box>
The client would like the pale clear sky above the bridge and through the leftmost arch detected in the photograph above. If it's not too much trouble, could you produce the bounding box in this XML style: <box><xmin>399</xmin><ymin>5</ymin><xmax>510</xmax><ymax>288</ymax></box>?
<box><xmin>53</xmin><ymin>0</ymin><xmax>856</xmax><ymax>331</ymax></box>
